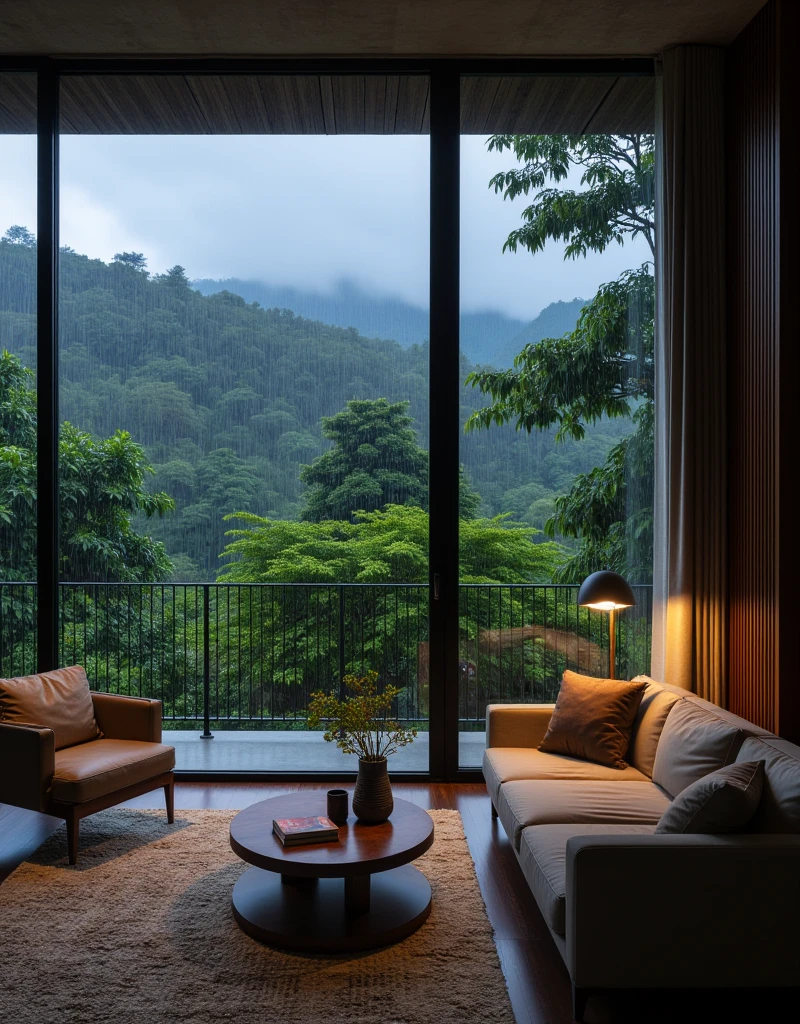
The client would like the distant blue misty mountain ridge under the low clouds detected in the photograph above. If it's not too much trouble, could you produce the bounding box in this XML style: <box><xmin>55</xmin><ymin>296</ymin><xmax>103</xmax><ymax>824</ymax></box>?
<box><xmin>192</xmin><ymin>278</ymin><xmax>584</xmax><ymax>368</ymax></box>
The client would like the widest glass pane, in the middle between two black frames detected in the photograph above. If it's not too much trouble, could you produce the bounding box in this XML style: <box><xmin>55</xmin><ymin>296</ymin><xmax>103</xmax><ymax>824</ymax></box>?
<box><xmin>59</xmin><ymin>75</ymin><xmax>430</xmax><ymax>772</ymax></box>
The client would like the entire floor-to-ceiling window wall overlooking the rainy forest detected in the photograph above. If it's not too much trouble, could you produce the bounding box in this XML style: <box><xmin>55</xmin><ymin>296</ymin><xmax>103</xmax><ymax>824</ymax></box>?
<box><xmin>0</xmin><ymin>60</ymin><xmax>655</xmax><ymax>774</ymax></box>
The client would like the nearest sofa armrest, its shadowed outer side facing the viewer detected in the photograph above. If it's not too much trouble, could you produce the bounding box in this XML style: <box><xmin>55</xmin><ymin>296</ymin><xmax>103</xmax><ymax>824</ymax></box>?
<box><xmin>566</xmin><ymin>835</ymin><xmax>800</xmax><ymax>989</ymax></box>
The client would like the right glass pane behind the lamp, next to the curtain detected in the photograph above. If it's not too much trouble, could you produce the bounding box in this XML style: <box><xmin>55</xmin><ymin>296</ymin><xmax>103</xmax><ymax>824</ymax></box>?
<box><xmin>458</xmin><ymin>76</ymin><xmax>655</xmax><ymax>768</ymax></box>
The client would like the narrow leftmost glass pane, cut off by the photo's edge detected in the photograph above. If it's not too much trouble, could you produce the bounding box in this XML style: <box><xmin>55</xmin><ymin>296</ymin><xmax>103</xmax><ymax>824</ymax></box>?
<box><xmin>0</xmin><ymin>74</ymin><xmax>37</xmax><ymax>676</ymax></box>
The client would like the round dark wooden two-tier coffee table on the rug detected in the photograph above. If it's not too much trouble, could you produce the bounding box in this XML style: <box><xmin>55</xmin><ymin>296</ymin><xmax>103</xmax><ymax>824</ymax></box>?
<box><xmin>230</xmin><ymin>790</ymin><xmax>433</xmax><ymax>952</ymax></box>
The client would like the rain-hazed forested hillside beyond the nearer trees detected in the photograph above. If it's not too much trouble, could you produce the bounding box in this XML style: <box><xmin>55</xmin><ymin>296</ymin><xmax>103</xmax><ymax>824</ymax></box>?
<box><xmin>0</xmin><ymin>239</ymin><xmax>630</xmax><ymax>580</ymax></box>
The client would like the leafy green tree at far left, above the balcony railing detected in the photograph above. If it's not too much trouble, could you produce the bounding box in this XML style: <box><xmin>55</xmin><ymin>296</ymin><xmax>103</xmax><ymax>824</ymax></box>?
<box><xmin>0</xmin><ymin>351</ymin><xmax>173</xmax><ymax>582</ymax></box>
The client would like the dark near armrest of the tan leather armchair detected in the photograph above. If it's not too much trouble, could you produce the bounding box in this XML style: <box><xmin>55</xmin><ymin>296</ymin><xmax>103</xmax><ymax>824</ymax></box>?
<box><xmin>0</xmin><ymin>723</ymin><xmax>55</xmax><ymax>811</ymax></box>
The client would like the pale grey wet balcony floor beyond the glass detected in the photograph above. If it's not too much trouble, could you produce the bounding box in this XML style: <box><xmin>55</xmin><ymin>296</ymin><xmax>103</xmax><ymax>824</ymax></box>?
<box><xmin>164</xmin><ymin>729</ymin><xmax>486</xmax><ymax>772</ymax></box>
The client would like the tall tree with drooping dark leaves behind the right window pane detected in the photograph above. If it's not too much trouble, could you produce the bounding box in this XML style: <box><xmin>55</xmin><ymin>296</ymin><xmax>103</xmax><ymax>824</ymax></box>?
<box><xmin>466</xmin><ymin>135</ymin><xmax>655</xmax><ymax>582</ymax></box>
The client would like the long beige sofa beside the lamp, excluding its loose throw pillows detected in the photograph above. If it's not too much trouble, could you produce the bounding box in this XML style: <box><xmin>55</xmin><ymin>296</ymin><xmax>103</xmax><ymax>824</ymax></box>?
<box><xmin>483</xmin><ymin>677</ymin><xmax>800</xmax><ymax>1020</ymax></box>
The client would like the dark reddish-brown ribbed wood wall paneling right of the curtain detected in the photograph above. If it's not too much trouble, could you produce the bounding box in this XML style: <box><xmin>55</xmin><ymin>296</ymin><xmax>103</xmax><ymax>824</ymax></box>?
<box><xmin>726</xmin><ymin>0</ymin><xmax>800</xmax><ymax>741</ymax></box>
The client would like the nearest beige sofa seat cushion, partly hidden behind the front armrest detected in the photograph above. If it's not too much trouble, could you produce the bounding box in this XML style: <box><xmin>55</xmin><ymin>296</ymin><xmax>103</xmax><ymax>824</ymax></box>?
<box><xmin>519</xmin><ymin>824</ymin><xmax>654</xmax><ymax>935</ymax></box>
